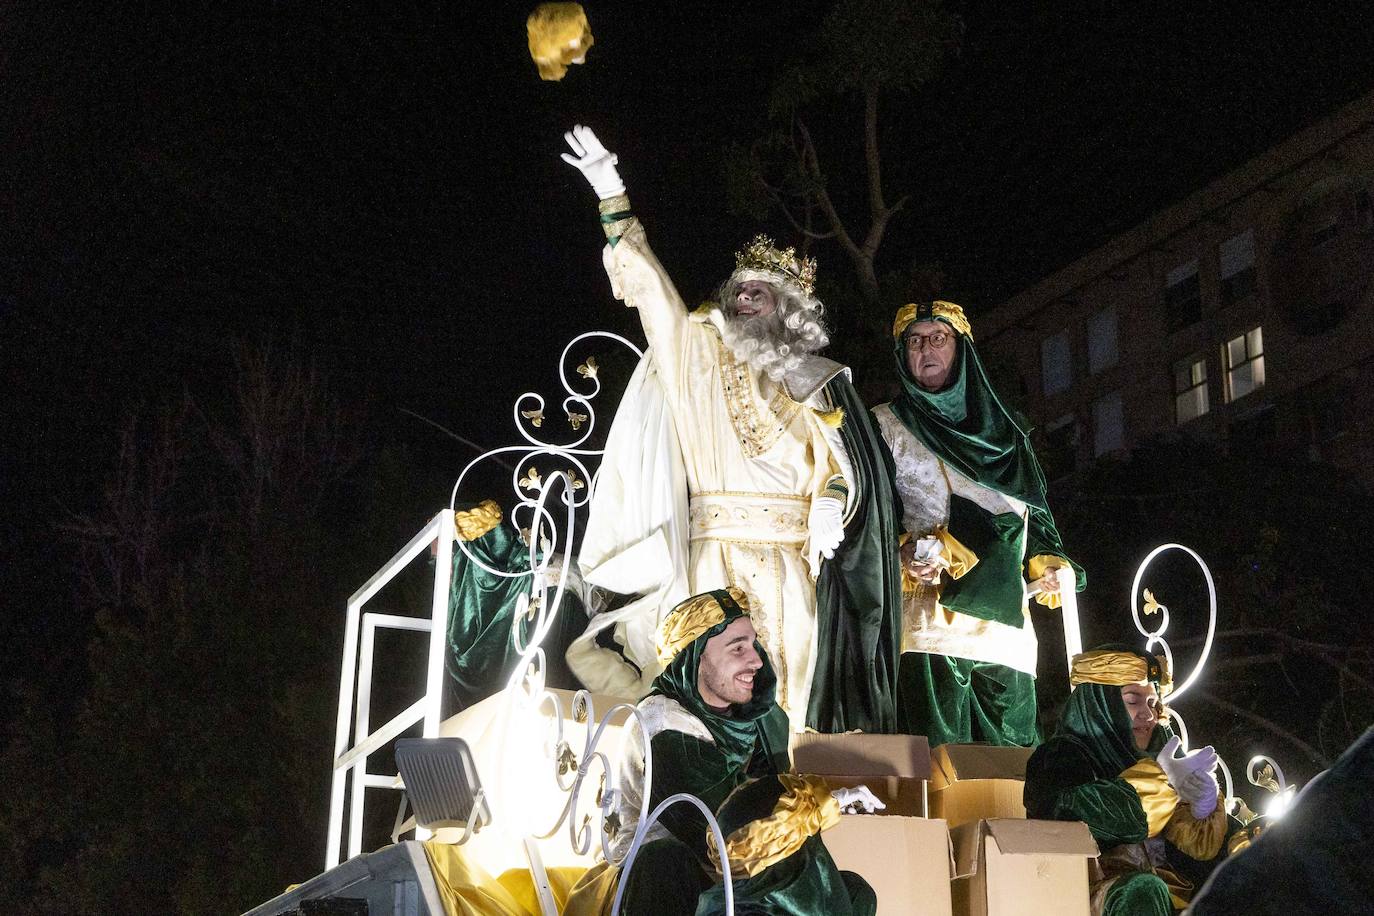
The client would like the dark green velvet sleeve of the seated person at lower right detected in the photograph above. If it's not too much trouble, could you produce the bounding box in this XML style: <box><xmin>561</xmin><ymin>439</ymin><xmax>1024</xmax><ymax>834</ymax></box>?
<box><xmin>1024</xmin><ymin>737</ymin><xmax>1150</xmax><ymax>850</ymax></box>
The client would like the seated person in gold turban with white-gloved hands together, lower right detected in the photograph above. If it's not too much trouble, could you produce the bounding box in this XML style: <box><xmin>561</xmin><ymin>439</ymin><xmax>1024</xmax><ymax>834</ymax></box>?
<box><xmin>1025</xmin><ymin>645</ymin><xmax>1239</xmax><ymax>916</ymax></box>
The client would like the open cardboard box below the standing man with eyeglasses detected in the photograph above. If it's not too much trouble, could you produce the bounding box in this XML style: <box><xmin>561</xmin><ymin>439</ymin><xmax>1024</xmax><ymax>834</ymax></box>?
<box><xmin>930</xmin><ymin>744</ymin><xmax>1032</xmax><ymax>829</ymax></box>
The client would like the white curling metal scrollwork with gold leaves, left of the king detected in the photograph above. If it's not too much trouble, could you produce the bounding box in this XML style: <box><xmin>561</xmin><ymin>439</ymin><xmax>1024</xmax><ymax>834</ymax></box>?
<box><xmin>449</xmin><ymin>331</ymin><xmax>734</xmax><ymax>916</ymax></box>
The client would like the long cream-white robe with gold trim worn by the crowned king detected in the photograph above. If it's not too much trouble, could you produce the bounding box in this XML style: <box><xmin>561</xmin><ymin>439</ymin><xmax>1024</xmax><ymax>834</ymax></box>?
<box><xmin>567</xmin><ymin>224</ymin><xmax>852</xmax><ymax>731</ymax></box>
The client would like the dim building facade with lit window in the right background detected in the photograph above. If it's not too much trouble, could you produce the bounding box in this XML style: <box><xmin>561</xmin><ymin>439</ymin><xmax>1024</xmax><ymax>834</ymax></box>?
<box><xmin>977</xmin><ymin>93</ymin><xmax>1374</xmax><ymax>483</ymax></box>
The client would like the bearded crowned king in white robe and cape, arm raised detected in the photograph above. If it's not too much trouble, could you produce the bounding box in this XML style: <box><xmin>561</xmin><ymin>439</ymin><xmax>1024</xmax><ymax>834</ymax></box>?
<box><xmin>563</xmin><ymin>126</ymin><xmax>900</xmax><ymax>732</ymax></box>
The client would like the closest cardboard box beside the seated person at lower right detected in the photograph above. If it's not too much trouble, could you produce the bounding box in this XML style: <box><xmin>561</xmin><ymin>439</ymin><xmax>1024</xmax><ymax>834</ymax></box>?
<box><xmin>949</xmin><ymin>818</ymin><xmax>1098</xmax><ymax>916</ymax></box>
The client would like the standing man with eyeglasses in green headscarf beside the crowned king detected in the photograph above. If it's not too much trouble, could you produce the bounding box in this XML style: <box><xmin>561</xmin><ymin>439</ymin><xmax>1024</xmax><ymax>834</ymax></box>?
<box><xmin>874</xmin><ymin>301</ymin><xmax>1084</xmax><ymax>747</ymax></box>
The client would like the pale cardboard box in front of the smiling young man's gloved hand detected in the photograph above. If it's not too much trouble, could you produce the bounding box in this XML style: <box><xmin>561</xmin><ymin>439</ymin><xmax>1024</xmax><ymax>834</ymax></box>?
<box><xmin>820</xmin><ymin>814</ymin><xmax>954</xmax><ymax>916</ymax></box>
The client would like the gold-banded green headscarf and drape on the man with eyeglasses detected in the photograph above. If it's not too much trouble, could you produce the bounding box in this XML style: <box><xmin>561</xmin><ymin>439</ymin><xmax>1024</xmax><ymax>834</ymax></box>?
<box><xmin>892</xmin><ymin>299</ymin><xmax>1087</xmax><ymax>628</ymax></box>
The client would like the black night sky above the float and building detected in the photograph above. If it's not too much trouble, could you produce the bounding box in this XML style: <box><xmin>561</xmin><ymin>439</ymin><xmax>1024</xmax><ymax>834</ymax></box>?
<box><xmin>0</xmin><ymin>0</ymin><xmax>1374</xmax><ymax>667</ymax></box>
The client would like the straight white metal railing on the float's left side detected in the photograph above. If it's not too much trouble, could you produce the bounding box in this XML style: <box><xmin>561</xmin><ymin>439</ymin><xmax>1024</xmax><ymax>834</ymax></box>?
<box><xmin>324</xmin><ymin>509</ymin><xmax>453</xmax><ymax>868</ymax></box>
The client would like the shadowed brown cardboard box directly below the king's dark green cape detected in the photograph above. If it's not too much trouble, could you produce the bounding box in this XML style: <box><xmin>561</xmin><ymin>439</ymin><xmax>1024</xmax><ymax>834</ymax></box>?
<box><xmin>791</xmin><ymin>732</ymin><xmax>930</xmax><ymax>817</ymax></box>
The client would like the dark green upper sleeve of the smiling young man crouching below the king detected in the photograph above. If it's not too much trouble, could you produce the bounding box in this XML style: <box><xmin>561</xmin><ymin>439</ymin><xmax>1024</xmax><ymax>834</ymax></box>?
<box><xmin>649</xmin><ymin>729</ymin><xmax>743</xmax><ymax>864</ymax></box>
